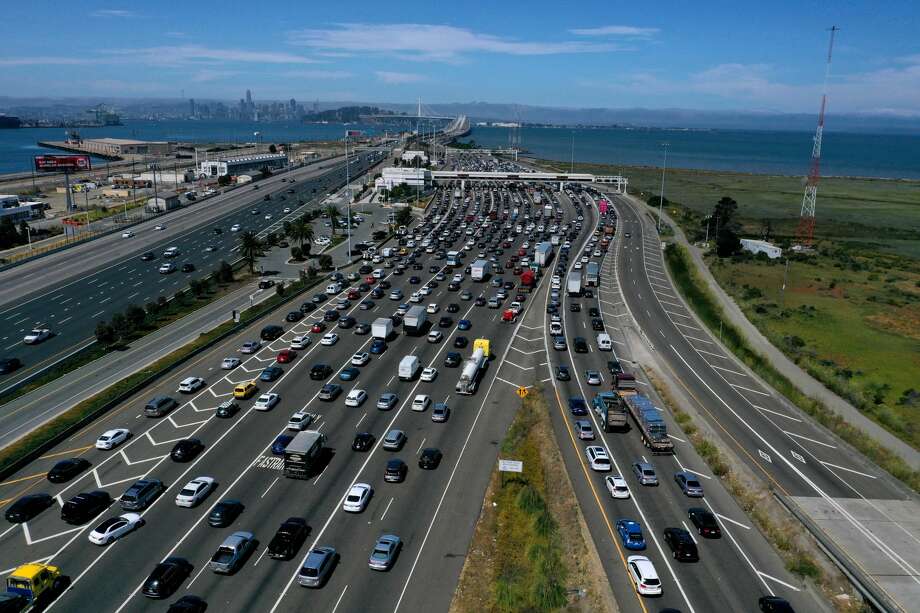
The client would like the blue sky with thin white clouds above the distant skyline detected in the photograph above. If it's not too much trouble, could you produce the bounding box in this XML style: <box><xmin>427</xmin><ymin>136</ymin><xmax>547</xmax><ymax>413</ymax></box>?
<box><xmin>0</xmin><ymin>0</ymin><xmax>920</xmax><ymax>115</ymax></box>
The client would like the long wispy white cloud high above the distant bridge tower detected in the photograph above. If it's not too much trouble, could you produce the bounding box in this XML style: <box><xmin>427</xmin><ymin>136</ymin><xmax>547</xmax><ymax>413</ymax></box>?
<box><xmin>288</xmin><ymin>23</ymin><xmax>615</xmax><ymax>62</ymax></box>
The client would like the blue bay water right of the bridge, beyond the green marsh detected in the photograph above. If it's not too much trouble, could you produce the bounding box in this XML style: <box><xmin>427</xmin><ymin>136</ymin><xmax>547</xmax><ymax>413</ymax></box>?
<box><xmin>465</xmin><ymin>127</ymin><xmax>920</xmax><ymax>179</ymax></box>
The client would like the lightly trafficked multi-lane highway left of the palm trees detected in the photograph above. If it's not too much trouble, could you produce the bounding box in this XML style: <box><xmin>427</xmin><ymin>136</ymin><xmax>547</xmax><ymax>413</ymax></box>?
<box><xmin>0</xmin><ymin>152</ymin><xmax>379</xmax><ymax>388</ymax></box>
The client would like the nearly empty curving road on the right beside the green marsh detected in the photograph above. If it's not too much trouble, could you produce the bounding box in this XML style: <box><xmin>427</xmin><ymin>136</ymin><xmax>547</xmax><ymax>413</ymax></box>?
<box><xmin>614</xmin><ymin>198</ymin><xmax>920</xmax><ymax>608</ymax></box>
